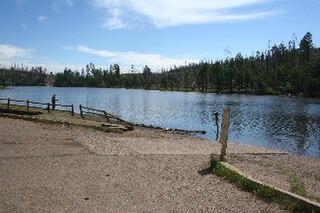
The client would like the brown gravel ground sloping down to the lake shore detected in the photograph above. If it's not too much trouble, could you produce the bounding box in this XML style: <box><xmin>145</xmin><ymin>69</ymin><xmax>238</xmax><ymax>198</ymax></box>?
<box><xmin>0</xmin><ymin>117</ymin><xmax>319</xmax><ymax>212</ymax></box>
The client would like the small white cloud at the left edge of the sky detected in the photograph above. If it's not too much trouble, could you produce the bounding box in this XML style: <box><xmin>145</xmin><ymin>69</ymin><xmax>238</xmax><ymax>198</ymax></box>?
<box><xmin>0</xmin><ymin>44</ymin><xmax>34</xmax><ymax>60</ymax></box>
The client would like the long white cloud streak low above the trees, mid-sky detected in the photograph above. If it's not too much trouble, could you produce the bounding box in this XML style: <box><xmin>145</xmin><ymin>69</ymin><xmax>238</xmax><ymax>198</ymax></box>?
<box><xmin>73</xmin><ymin>46</ymin><xmax>198</xmax><ymax>70</ymax></box>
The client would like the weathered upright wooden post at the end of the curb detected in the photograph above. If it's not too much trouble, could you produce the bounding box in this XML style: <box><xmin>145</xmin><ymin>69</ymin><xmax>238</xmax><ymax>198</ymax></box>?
<box><xmin>219</xmin><ymin>108</ymin><xmax>230</xmax><ymax>161</ymax></box>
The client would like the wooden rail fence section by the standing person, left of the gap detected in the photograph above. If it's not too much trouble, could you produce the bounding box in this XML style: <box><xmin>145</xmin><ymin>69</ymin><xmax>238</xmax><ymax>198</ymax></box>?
<box><xmin>0</xmin><ymin>98</ymin><xmax>74</xmax><ymax>116</ymax></box>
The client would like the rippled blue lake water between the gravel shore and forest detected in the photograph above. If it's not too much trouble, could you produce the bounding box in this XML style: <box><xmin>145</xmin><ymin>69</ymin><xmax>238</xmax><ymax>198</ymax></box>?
<box><xmin>0</xmin><ymin>87</ymin><xmax>320</xmax><ymax>158</ymax></box>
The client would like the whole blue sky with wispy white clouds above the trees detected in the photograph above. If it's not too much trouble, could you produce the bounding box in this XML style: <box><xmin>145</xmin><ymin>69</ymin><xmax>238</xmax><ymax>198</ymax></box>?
<box><xmin>0</xmin><ymin>0</ymin><xmax>320</xmax><ymax>73</ymax></box>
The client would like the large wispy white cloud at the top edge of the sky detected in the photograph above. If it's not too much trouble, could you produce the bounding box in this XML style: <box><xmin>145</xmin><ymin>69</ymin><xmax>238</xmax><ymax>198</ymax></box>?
<box><xmin>95</xmin><ymin>0</ymin><xmax>276</xmax><ymax>28</ymax></box>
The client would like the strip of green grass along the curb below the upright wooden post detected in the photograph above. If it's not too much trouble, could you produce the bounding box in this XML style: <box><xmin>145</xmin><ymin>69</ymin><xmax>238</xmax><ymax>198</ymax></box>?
<box><xmin>210</xmin><ymin>155</ymin><xmax>320</xmax><ymax>212</ymax></box>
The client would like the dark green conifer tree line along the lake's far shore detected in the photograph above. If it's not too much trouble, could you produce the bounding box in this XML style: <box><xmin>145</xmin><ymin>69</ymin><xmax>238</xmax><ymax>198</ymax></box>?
<box><xmin>0</xmin><ymin>32</ymin><xmax>320</xmax><ymax>97</ymax></box>
